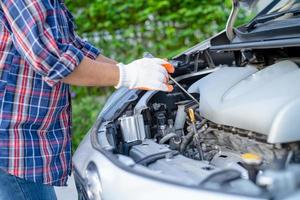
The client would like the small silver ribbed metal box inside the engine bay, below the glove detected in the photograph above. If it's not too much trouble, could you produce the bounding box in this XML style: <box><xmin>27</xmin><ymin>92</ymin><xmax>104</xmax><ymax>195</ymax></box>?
<box><xmin>119</xmin><ymin>114</ymin><xmax>146</xmax><ymax>143</ymax></box>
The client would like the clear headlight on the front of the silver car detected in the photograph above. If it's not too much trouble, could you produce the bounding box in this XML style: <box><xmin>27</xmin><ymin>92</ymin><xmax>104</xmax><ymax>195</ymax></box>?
<box><xmin>85</xmin><ymin>162</ymin><xmax>102</xmax><ymax>200</ymax></box>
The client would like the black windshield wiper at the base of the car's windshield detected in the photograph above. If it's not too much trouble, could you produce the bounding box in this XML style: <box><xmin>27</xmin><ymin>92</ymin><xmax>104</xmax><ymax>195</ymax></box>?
<box><xmin>247</xmin><ymin>9</ymin><xmax>300</xmax><ymax>31</ymax></box>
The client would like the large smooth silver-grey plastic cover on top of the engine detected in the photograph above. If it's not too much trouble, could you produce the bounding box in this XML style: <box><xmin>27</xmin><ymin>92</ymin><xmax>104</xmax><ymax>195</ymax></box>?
<box><xmin>189</xmin><ymin>61</ymin><xmax>300</xmax><ymax>143</ymax></box>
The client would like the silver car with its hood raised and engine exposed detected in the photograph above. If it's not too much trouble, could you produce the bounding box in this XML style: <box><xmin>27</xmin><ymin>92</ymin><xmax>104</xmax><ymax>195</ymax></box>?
<box><xmin>73</xmin><ymin>0</ymin><xmax>300</xmax><ymax>200</ymax></box>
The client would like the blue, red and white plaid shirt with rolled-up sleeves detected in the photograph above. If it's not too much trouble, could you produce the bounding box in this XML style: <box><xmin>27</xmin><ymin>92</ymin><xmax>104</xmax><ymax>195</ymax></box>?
<box><xmin>0</xmin><ymin>0</ymin><xmax>100</xmax><ymax>186</ymax></box>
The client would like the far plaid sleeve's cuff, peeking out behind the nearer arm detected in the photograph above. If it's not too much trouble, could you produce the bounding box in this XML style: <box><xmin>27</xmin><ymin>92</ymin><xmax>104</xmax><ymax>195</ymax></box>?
<box><xmin>74</xmin><ymin>35</ymin><xmax>101</xmax><ymax>60</ymax></box>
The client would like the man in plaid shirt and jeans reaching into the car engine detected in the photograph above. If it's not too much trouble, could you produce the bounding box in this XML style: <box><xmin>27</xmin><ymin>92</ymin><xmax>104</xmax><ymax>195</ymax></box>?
<box><xmin>0</xmin><ymin>0</ymin><xmax>174</xmax><ymax>200</ymax></box>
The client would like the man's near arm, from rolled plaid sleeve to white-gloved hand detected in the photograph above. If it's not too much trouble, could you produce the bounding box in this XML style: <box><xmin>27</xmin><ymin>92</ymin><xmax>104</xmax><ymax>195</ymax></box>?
<box><xmin>0</xmin><ymin>0</ymin><xmax>174</xmax><ymax>91</ymax></box>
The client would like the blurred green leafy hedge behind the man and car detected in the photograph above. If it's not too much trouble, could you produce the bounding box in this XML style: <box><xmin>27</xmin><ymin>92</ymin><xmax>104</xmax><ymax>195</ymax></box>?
<box><xmin>65</xmin><ymin>0</ymin><xmax>251</xmax><ymax>151</ymax></box>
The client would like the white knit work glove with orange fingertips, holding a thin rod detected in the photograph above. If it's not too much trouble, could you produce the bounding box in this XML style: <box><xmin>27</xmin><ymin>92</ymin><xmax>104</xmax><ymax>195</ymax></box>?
<box><xmin>116</xmin><ymin>58</ymin><xmax>174</xmax><ymax>92</ymax></box>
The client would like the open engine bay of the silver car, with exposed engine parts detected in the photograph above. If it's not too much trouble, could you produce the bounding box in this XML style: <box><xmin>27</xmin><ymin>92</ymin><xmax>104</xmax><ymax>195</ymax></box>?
<box><xmin>101</xmin><ymin>47</ymin><xmax>300</xmax><ymax>199</ymax></box>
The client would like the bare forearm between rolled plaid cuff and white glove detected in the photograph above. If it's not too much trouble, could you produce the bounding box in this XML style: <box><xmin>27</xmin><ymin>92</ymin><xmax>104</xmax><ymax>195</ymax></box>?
<box><xmin>62</xmin><ymin>56</ymin><xmax>119</xmax><ymax>86</ymax></box>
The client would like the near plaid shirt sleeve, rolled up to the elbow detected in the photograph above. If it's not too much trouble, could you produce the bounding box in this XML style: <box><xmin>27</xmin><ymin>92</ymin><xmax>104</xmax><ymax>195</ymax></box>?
<box><xmin>0</xmin><ymin>0</ymin><xmax>84</xmax><ymax>86</ymax></box>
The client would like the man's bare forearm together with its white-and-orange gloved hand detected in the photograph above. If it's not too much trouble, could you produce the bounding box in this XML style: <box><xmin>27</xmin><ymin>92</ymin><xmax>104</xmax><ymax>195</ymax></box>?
<box><xmin>62</xmin><ymin>57</ymin><xmax>174</xmax><ymax>91</ymax></box>
